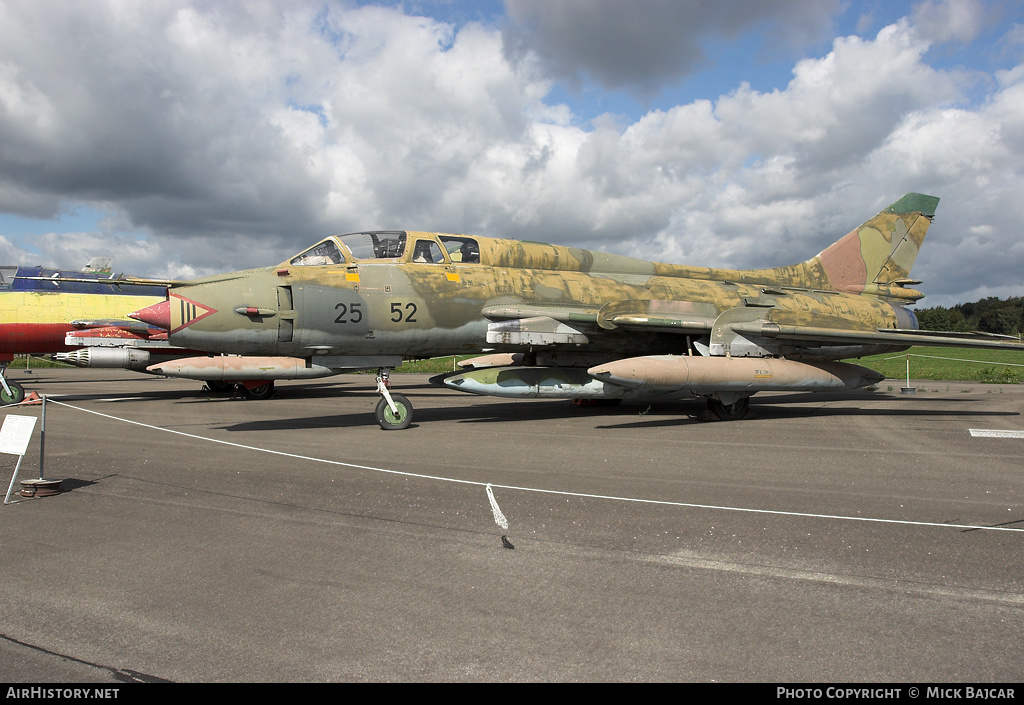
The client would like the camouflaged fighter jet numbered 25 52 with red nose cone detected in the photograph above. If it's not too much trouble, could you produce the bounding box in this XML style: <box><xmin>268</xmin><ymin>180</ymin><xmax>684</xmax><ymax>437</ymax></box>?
<box><xmin>130</xmin><ymin>194</ymin><xmax>1024</xmax><ymax>429</ymax></box>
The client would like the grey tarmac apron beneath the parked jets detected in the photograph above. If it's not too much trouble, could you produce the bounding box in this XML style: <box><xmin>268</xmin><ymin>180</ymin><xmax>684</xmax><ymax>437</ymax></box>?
<box><xmin>0</xmin><ymin>369</ymin><xmax>1024</xmax><ymax>685</ymax></box>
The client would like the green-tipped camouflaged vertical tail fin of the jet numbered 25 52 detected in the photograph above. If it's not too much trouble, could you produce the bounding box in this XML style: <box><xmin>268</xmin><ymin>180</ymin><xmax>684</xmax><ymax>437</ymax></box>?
<box><xmin>807</xmin><ymin>194</ymin><xmax>939</xmax><ymax>298</ymax></box>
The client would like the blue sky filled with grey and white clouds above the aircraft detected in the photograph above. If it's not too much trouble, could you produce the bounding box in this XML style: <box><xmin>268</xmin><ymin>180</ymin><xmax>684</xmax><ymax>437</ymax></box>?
<box><xmin>0</xmin><ymin>0</ymin><xmax>1024</xmax><ymax>305</ymax></box>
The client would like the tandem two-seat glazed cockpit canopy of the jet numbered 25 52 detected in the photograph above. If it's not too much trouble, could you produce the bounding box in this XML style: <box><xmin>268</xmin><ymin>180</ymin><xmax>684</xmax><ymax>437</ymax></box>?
<box><xmin>288</xmin><ymin>231</ymin><xmax>480</xmax><ymax>266</ymax></box>
